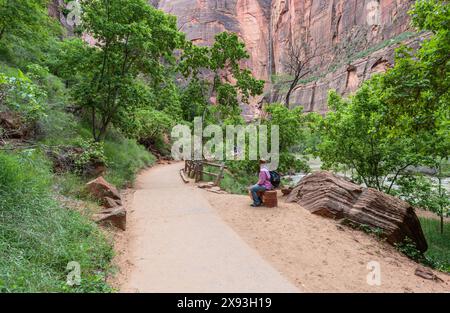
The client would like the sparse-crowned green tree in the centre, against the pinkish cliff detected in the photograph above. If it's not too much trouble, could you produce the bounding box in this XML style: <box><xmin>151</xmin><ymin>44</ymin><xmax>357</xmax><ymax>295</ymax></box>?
<box><xmin>179</xmin><ymin>32</ymin><xmax>264</xmax><ymax>121</ymax></box>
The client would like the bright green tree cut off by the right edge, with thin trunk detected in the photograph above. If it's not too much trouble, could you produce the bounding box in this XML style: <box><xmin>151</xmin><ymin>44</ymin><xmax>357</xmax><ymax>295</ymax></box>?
<box><xmin>383</xmin><ymin>0</ymin><xmax>450</xmax><ymax>231</ymax></box>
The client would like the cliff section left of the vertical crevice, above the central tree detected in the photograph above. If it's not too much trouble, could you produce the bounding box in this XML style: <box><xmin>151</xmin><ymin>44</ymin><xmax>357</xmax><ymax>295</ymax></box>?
<box><xmin>155</xmin><ymin>0</ymin><xmax>271</xmax><ymax>79</ymax></box>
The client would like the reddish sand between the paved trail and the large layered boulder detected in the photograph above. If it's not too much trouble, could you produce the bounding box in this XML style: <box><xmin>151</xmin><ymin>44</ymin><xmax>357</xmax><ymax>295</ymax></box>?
<box><xmin>203</xmin><ymin>191</ymin><xmax>450</xmax><ymax>292</ymax></box>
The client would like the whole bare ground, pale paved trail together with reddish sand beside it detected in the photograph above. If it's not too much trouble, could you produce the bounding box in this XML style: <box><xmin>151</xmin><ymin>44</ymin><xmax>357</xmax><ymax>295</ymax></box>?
<box><xmin>109</xmin><ymin>164</ymin><xmax>450</xmax><ymax>292</ymax></box>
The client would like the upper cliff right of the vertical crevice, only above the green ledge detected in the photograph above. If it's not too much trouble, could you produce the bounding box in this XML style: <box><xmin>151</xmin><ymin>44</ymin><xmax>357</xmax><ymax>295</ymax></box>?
<box><xmin>271</xmin><ymin>0</ymin><xmax>414</xmax><ymax>73</ymax></box>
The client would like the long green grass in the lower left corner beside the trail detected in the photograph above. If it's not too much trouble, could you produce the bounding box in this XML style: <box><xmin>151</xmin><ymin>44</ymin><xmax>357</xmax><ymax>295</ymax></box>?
<box><xmin>0</xmin><ymin>151</ymin><xmax>113</xmax><ymax>292</ymax></box>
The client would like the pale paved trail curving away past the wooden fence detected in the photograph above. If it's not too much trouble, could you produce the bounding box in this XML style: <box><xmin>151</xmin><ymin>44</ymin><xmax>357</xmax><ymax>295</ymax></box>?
<box><xmin>120</xmin><ymin>163</ymin><xmax>300</xmax><ymax>293</ymax></box>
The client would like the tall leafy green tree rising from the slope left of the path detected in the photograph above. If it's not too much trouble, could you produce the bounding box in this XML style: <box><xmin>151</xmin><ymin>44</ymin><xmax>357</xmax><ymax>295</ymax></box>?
<box><xmin>70</xmin><ymin>0</ymin><xmax>184</xmax><ymax>141</ymax></box>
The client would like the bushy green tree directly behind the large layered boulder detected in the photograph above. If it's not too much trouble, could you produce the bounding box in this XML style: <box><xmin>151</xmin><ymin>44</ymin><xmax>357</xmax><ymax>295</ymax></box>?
<box><xmin>318</xmin><ymin>76</ymin><xmax>422</xmax><ymax>193</ymax></box>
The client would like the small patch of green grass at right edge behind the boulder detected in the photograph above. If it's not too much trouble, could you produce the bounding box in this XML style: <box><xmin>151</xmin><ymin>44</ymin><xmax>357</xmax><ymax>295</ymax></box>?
<box><xmin>420</xmin><ymin>218</ymin><xmax>450</xmax><ymax>272</ymax></box>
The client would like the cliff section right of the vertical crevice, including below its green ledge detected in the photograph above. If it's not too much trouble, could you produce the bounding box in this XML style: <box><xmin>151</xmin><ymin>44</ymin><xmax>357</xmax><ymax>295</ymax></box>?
<box><xmin>270</xmin><ymin>0</ymin><xmax>417</xmax><ymax>113</ymax></box>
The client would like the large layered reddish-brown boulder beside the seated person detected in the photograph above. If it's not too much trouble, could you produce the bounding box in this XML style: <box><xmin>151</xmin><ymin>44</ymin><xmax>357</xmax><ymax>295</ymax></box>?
<box><xmin>287</xmin><ymin>172</ymin><xmax>428</xmax><ymax>252</ymax></box>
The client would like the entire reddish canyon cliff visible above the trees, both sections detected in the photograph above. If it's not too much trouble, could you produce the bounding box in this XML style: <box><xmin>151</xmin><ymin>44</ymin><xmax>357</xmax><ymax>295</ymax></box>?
<box><xmin>153</xmin><ymin>0</ymin><xmax>414</xmax><ymax>113</ymax></box>
